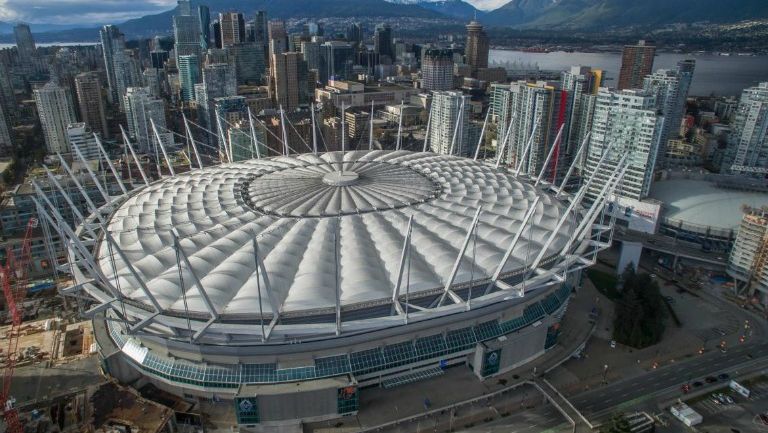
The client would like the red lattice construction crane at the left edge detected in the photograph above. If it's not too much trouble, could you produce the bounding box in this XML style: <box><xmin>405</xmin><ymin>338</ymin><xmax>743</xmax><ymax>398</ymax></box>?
<box><xmin>0</xmin><ymin>218</ymin><xmax>37</xmax><ymax>433</ymax></box>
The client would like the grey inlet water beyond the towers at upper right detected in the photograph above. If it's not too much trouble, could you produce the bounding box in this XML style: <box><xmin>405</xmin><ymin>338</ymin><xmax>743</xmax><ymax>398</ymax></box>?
<box><xmin>490</xmin><ymin>50</ymin><xmax>768</xmax><ymax>96</ymax></box>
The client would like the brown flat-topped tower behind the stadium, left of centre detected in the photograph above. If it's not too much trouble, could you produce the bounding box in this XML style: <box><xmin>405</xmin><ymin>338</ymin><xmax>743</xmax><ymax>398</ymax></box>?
<box><xmin>270</xmin><ymin>53</ymin><xmax>310</xmax><ymax>111</ymax></box>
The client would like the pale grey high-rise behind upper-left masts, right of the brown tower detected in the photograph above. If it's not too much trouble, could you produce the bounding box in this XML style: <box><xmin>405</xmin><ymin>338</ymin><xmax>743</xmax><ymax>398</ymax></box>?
<box><xmin>125</xmin><ymin>87</ymin><xmax>173</xmax><ymax>154</ymax></box>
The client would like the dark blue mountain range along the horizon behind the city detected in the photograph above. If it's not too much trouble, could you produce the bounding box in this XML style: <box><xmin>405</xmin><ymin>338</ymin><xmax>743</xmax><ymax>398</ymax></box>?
<box><xmin>0</xmin><ymin>0</ymin><xmax>768</xmax><ymax>41</ymax></box>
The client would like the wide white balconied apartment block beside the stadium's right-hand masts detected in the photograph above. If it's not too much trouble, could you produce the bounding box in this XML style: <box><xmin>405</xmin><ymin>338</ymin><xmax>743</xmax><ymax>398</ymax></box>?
<box><xmin>586</xmin><ymin>88</ymin><xmax>664</xmax><ymax>200</ymax></box>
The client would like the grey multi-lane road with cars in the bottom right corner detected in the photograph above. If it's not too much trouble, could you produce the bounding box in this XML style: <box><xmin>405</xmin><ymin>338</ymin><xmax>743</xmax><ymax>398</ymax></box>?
<box><xmin>570</xmin><ymin>343</ymin><xmax>768</xmax><ymax>419</ymax></box>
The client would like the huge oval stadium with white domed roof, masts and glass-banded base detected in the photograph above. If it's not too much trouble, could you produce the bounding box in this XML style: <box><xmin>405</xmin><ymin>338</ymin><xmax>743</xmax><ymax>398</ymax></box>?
<box><xmin>48</xmin><ymin>151</ymin><xmax>621</xmax><ymax>428</ymax></box>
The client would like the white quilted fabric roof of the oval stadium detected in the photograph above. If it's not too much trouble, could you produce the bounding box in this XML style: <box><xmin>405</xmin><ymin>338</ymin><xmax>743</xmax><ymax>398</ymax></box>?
<box><xmin>99</xmin><ymin>151</ymin><xmax>579</xmax><ymax>315</ymax></box>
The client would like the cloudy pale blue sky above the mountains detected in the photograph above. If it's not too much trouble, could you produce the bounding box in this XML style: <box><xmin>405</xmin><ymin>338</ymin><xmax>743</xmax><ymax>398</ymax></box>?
<box><xmin>0</xmin><ymin>0</ymin><xmax>509</xmax><ymax>25</ymax></box>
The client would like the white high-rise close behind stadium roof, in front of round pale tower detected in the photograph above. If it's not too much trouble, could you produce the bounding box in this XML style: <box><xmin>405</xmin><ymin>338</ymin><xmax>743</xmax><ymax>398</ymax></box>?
<box><xmin>428</xmin><ymin>91</ymin><xmax>477</xmax><ymax>156</ymax></box>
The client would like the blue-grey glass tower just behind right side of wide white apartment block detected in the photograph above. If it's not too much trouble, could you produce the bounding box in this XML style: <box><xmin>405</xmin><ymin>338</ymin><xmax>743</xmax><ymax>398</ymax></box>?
<box><xmin>643</xmin><ymin>60</ymin><xmax>696</xmax><ymax>163</ymax></box>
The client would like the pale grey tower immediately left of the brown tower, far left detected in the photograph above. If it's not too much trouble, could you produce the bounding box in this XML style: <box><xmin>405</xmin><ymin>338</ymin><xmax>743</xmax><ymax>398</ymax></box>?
<box><xmin>34</xmin><ymin>81</ymin><xmax>76</xmax><ymax>153</ymax></box>
